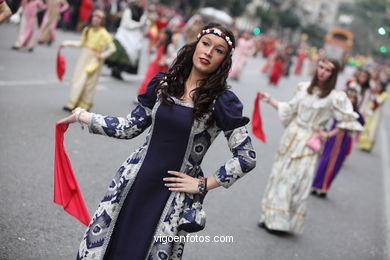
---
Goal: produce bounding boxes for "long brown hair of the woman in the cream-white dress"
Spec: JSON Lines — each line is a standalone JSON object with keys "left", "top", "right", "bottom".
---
{"left": 307, "top": 58, "right": 340, "bottom": 98}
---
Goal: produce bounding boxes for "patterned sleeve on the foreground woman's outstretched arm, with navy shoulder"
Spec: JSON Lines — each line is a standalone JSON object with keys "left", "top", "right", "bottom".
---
{"left": 88, "top": 73, "right": 162, "bottom": 139}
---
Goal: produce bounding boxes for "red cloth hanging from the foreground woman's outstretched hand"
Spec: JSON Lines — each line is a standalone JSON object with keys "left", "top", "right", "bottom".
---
{"left": 54, "top": 124, "right": 91, "bottom": 226}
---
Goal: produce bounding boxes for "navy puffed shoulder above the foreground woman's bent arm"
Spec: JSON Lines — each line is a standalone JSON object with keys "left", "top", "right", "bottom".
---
{"left": 214, "top": 90, "right": 249, "bottom": 131}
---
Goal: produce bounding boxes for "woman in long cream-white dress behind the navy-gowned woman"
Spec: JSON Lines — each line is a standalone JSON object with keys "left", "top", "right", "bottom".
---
{"left": 259, "top": 59, "right": 363, "bottom": 233}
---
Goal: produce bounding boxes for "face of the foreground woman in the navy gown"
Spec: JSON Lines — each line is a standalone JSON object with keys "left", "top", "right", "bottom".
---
{"left": 192, "top": 34, "right": 229, "bottom": 74}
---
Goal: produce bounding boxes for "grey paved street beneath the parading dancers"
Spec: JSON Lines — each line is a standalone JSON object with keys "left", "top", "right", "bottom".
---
{"left": 0, "top": 24, "right": 390, "bottom": 260}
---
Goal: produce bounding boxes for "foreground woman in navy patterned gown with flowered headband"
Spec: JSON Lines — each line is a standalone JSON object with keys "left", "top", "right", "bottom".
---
{"left": 60, "top": 24, "right": 256, "bottom": 260}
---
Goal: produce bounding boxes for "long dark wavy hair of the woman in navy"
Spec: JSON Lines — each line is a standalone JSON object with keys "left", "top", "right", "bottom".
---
{"left": 156, "top": 23, "right": 235, "bottom": 125}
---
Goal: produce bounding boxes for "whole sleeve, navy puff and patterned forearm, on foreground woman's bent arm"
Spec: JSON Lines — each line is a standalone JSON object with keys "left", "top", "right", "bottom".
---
{"left": 214, "top": 91, "right": 256, "bottom": 188}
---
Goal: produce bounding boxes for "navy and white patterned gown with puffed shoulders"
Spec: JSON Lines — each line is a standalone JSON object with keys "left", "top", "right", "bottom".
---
{"left": 77, "top": 73, "right": 256, "bottom": 259}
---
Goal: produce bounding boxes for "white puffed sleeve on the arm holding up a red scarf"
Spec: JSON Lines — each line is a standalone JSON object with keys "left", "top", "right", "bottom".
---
{"left": 278, "top": 82, "right": 310, "bottom": 127}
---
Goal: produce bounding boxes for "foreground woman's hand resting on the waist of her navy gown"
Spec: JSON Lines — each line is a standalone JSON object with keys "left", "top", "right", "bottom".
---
{"left": 163, "top": 171, "right": 199, "bottom": 194}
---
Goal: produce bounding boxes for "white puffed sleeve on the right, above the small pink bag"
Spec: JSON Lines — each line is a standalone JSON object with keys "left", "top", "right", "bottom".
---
{"left": 331, "top": 90, "right": 364, "bottom": 131}
